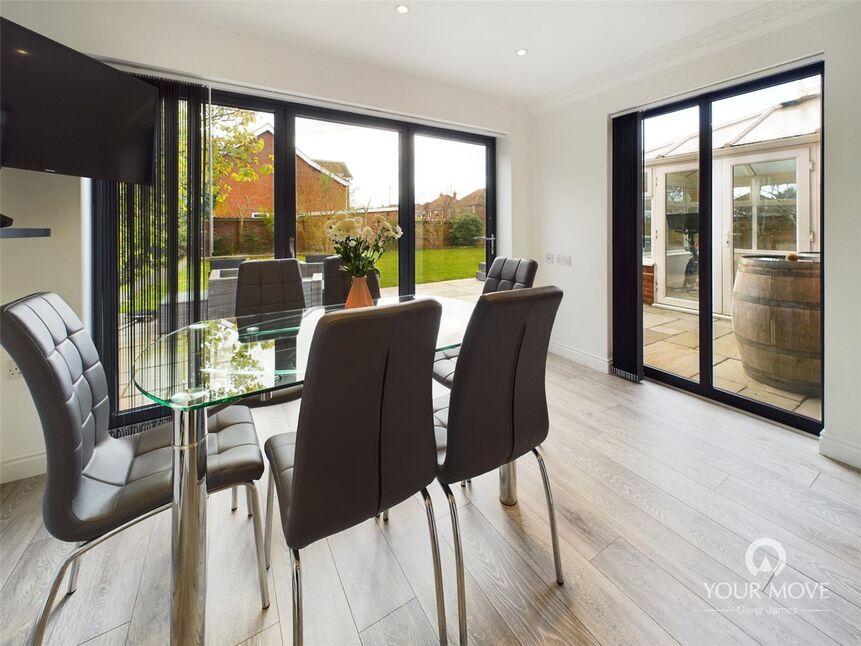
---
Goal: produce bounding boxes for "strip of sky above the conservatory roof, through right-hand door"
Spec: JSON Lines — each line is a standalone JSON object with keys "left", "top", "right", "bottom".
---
{"left": 643, "top": 76, "right": 820, "bottom": 150}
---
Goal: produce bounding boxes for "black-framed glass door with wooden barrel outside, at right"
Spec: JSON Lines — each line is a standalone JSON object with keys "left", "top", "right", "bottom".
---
{"left": 636, "top": 65, "right": 824, "bottom": 433}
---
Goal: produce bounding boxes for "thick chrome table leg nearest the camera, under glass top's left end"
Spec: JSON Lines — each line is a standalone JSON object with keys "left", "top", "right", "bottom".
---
{"left": 170, "top": 409, "right": 207, "bottom": 646}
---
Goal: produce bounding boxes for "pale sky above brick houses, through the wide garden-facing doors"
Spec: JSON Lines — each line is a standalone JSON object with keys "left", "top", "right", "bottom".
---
{"left": 235, "top": 113, "right": 486, "bottom": 206}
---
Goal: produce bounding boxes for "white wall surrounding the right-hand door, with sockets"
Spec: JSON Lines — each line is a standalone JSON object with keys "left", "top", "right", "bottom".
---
{"left": 530, "top": 3, "right": 861, "bottom": 467}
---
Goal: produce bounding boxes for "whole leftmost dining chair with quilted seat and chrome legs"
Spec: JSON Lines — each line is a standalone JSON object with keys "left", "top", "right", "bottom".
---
{"left": 0, "top": 293, "right": 269, "bottom": 644}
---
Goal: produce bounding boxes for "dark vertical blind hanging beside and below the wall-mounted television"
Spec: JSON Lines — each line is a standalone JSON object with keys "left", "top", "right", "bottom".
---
{"left": 93, "top": 76, "right": 209, "bottom": 430}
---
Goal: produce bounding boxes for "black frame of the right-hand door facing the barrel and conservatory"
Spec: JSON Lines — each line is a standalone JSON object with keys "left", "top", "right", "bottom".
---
{"left": 636, "top": 62, "right": 825, "bottom": 435}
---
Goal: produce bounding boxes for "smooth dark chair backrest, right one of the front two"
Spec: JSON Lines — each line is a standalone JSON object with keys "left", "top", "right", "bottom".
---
{"left": 440, "top": 287, "right": 562, "bottom": 482}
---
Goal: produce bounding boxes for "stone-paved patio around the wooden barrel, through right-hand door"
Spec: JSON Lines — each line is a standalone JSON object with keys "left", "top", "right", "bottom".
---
{"left": 643, "top": 305, "right": 822, "bottom": 419}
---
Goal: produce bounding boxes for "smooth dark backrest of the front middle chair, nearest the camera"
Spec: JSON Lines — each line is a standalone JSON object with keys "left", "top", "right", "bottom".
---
{"left": 285, "top": 300, "right": 442, "bottom": 549}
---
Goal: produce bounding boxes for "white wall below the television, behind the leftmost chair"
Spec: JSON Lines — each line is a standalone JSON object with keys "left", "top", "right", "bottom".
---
{"left": 0, "top": 168, "right": 86, "bottom": 482}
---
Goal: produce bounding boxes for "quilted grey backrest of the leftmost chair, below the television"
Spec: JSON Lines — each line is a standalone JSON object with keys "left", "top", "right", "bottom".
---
{"left": 0, "top": 293, "right": 110, "bottom": 538}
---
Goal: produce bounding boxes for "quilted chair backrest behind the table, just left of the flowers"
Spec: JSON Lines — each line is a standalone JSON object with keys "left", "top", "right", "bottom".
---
{"left": 235, "top": 258, "right": 305, "bottom": 316}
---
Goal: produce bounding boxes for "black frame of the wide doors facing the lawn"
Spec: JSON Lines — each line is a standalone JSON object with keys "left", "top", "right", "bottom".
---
{"left": 211, "top": 90, "right": 498, "bottom": 294}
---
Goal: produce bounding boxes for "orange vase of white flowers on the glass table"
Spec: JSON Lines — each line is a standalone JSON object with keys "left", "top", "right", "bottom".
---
{"left": 326, "top": 216, "right": 403, "bottom": 308}
